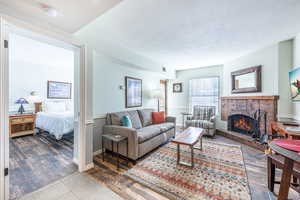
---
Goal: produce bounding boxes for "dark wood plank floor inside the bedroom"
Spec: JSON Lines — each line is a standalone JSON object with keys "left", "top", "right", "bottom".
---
{"left": 9, "top": 133, "right": 77, "bottom": 199}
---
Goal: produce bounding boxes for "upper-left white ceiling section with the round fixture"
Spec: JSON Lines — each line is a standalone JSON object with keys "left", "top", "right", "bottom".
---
{"left": 0, "top": 0, "right": 121, "bottom": 33}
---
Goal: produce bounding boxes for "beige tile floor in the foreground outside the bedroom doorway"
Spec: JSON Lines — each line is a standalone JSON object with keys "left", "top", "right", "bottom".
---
{"left": 20, "top": 172, "right": 122, "bottom": 200}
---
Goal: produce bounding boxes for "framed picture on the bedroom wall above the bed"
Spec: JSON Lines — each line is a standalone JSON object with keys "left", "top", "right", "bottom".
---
{"left": 47, "top": 81, "right": 72, "bottom": 99}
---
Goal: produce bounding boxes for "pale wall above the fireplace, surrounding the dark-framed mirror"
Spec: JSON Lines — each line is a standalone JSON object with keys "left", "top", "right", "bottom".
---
{"left": 223, "top": 40, "right": 293, "bottom": 118}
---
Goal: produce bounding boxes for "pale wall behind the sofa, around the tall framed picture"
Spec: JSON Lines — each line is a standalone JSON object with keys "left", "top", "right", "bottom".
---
{"left": 92, "top": 50, "right": 166, "bottom": 152}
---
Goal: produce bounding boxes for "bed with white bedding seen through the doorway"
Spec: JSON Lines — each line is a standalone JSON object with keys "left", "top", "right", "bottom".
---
{"left": 36, "top": 102, "right": 74, "bottom": 140}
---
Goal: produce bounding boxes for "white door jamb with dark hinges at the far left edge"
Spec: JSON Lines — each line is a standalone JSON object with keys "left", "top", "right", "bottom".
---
{"left": 0, "top": 18, "right": 9, "bottom": 200}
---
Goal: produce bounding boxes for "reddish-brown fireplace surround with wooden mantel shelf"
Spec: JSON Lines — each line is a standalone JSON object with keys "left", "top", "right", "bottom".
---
{"left": 221, "top": 95, "right": 279, "bottom": 132}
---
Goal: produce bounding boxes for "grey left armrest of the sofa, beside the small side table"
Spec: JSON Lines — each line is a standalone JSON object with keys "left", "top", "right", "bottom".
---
{"left": 103, "top": 125, "right": 138, "bottom": 159}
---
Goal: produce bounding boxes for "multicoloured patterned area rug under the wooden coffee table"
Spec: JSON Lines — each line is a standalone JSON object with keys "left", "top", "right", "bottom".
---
{"left": 124, "top": 141, "right": 251, "bottom": 200}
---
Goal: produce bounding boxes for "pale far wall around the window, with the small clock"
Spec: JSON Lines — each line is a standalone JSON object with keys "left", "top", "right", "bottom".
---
{"left": 168, "top": 65, "right": 223, "bottom": 125}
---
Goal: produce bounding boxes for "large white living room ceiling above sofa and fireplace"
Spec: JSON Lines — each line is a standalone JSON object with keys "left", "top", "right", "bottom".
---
{"left": 77, "top": 0, "right": 300, "bottom": 69}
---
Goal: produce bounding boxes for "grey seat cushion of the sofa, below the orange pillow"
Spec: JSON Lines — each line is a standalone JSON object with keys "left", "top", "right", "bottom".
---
{"left": 137, "top": 122, "right": 175, "bottom": 144}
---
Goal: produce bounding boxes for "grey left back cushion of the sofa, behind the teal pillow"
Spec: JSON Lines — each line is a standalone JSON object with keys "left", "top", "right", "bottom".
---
{"left": 110, "top": 110, "right": 142, "bottom": 129}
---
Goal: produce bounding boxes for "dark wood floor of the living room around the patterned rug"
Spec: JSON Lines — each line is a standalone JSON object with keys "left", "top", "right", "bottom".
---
{"left": 87, "top": 132, "right": 299, "bottom": 200}
